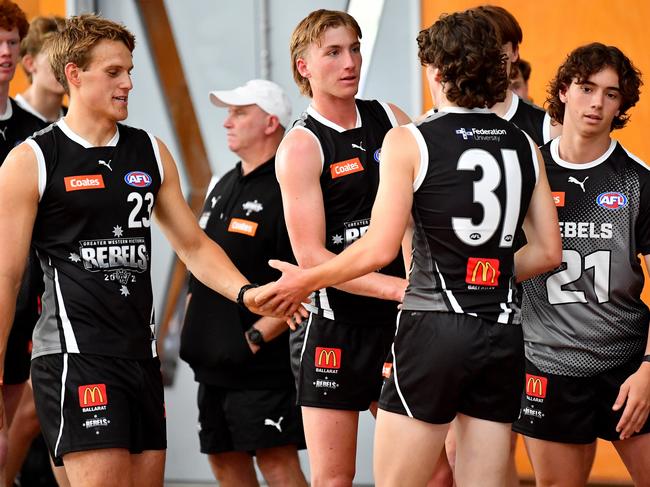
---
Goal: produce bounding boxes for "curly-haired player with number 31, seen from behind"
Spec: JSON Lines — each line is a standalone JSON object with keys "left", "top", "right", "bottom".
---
{"left": 259, "top": 11, "right": 561, "bottom": 486}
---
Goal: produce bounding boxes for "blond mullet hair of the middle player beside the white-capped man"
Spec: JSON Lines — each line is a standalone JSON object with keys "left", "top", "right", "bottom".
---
{"left": 289, "top": 9, "right": 361, "bottom": 97}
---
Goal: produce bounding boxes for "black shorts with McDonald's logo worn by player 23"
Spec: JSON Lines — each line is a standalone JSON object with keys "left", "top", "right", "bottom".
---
{"left": 32, "top": 353, "right": 167, "bottom": 466}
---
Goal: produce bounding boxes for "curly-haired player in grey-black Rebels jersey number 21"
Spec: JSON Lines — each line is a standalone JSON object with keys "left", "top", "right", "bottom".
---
{"left": 514, "top": 43, "right": 650, "bottom": 486}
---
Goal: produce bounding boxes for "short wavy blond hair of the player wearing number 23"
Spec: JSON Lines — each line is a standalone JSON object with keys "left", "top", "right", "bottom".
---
{"left": 47, "top": 14, "right": 135, "bottom": 93}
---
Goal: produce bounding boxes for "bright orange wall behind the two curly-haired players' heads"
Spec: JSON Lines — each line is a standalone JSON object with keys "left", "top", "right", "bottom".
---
{"left": 414, "top": 0, "right": 650, "bottom": 163}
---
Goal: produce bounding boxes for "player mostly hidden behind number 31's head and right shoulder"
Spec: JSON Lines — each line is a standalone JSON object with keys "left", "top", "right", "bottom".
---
{"left": 476, "top": 5, "right": 562, "bottom": 146}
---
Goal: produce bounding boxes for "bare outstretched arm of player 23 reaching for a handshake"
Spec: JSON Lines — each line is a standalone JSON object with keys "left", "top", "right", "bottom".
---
{"left": 154, "top": 141, "right": 297, "bottom": 316}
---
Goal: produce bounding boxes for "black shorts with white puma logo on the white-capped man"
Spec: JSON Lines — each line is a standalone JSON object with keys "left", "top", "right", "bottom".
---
{"left": 197, "top": 384, "right": 305, "bottom": 455}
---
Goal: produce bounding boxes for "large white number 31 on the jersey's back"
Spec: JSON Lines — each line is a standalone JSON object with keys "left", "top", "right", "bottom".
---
{"left": 451, "top": 149, "right": 521, "bottom": 247}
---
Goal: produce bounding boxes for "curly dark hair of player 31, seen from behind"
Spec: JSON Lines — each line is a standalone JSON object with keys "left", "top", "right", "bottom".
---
{"left": 417, "top": 10, "right": 508, "bottom": 108}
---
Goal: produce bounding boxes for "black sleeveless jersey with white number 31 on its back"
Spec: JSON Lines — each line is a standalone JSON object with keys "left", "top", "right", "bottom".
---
{"left": 402, "top": 107, "right": 539, "bottom": 324}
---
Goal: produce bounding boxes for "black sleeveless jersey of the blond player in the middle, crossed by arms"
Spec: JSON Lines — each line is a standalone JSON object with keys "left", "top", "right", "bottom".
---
{"left": 292, "top": 100, "right": 405, "bottom": 324}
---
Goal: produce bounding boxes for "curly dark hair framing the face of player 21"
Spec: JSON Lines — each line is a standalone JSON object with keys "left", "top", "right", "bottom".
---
{"left": 546, "top": 42, "right": 643, "bottom": 130}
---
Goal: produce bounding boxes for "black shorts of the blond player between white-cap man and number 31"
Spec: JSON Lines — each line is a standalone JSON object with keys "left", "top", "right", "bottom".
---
{"left": 289, "top": 313, "right": 395, "bottom": 411}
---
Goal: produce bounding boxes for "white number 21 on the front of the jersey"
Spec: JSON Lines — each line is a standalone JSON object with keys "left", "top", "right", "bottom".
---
{"left": 546, "top": 250, "right": 611, "bottom": 304}
